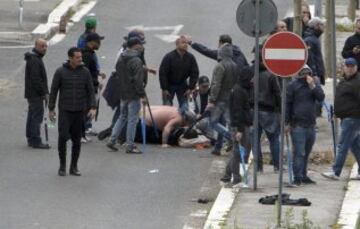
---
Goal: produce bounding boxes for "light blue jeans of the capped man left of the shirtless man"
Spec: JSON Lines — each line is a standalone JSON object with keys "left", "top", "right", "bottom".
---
{"left": 110, "top": 99, "right": 140, "bottom": 148}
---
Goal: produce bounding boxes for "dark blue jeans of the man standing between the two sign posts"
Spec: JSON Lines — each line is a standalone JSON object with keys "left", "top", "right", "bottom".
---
{"left": 252, "top": 111, "right": 280, "bottom": 170}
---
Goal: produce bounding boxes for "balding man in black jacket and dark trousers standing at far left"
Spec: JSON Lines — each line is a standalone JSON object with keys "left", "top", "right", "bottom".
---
{"left": 25, "top": 39, "right": 50, "bottom": 149}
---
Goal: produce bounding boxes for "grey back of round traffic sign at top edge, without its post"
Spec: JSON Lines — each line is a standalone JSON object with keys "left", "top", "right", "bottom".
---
{"left": 236, "top": 0, "right": 278, "bottom": 37}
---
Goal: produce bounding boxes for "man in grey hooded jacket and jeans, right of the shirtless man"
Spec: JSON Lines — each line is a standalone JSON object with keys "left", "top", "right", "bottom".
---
{"left": 206, "top": 43, "right": 237, "bottom": 155}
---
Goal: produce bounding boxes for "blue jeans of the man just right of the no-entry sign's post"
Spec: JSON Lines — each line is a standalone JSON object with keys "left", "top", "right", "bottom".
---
{"left": 291, "top": 126, "right": 315, "bottom": 181}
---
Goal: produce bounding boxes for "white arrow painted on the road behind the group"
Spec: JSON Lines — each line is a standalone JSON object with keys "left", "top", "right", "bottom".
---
{"left": 125, "top": 24, "right": 184, "bottom": 43}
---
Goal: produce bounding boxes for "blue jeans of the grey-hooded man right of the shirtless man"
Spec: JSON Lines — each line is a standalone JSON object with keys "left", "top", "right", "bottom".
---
{"left": 210, "top": 102, "right": 232, "bottom": 150}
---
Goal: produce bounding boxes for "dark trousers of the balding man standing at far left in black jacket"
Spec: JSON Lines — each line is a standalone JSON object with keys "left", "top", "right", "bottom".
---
{"left": 26, "top": 98, "right": 44, "bottom": 145}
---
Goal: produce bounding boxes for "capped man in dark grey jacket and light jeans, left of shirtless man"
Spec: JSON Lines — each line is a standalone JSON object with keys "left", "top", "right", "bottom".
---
{"left": 106, "top": 37, "right": 146, "bottom": 154}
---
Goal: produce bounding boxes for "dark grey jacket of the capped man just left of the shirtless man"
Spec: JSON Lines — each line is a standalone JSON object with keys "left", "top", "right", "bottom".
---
{"left": 116, "top": 49, "right": 145, "bottom": 100}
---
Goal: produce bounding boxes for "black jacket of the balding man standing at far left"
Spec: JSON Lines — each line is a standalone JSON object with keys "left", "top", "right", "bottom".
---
{"left": 24, "top": 49, "right": 49, "bottom": 99}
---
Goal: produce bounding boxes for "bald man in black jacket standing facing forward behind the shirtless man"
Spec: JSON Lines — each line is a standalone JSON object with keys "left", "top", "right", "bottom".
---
{"left": 159, "top": 36, "right": 199, "bottom": 107}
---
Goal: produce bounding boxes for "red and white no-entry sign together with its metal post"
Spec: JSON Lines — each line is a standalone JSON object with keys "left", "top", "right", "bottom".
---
{"left": 262, "top": 32, "right": 308, "bottom": 227}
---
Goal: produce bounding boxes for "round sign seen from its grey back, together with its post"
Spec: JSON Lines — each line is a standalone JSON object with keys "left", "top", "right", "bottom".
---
{"left": 236, "top": 0, "right": 278, "bottom": 190}
